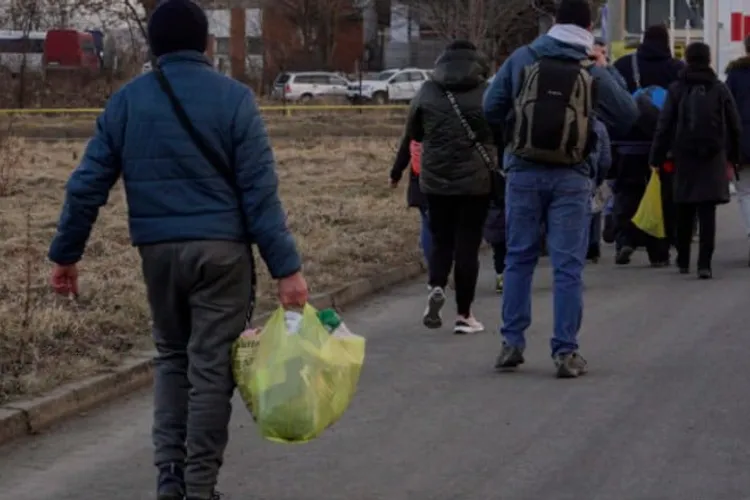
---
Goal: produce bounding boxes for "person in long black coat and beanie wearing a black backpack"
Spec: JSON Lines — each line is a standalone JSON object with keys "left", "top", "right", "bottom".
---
{"left": 650, "top": 42, "right": 742, "bottom": 279}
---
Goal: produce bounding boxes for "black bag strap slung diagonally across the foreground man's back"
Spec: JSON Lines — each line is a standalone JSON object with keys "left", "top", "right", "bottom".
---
{"left": 152, "top": 61, "right": 258, "bottom": 326}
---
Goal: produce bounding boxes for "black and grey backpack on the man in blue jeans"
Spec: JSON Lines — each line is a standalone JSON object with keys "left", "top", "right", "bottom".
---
{"left": 509, "top": 53, "right": 594, "bottom": 166}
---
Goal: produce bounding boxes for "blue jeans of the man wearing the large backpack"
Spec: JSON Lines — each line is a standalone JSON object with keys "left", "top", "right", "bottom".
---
{"left": 500, "top": 168, "right": 591, "bottom": 356}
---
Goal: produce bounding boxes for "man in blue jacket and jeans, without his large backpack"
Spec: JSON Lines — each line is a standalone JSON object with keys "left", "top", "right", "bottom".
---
{"left": 484, "top": 0, "right": 638, "bottom": 378}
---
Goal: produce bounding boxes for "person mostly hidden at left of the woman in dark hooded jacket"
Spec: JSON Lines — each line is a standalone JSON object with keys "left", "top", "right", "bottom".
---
{"left": 391, "top": 137, "right": 432, "bottom": 265}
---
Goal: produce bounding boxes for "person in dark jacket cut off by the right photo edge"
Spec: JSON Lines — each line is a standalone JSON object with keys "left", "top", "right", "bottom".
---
{"left": 726, "top": 37, "right": 750, "bottom": 266}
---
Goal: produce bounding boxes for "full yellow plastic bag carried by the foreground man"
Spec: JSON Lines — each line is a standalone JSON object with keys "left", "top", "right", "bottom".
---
{"left": 247, "top": 305, "right": 365, "bottom": 443}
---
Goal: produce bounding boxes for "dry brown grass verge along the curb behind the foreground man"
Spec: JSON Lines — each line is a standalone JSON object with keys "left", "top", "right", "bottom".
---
{"left": 0, "top": 137, "right": 419, "bottom": 403}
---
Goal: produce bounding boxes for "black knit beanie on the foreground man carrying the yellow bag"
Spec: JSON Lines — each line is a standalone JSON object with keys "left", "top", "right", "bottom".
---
{"left": 148, "top": 0, "right": 208, "bottom": 57}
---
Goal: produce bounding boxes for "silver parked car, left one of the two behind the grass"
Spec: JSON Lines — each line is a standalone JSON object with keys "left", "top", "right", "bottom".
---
{"left": 271, "top": 71, "right": 349, "bottom": 102}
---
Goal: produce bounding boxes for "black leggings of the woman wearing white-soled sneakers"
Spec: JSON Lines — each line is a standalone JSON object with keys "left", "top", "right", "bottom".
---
{"left": 427, "top": 194, "right": 490, "bottom": 316}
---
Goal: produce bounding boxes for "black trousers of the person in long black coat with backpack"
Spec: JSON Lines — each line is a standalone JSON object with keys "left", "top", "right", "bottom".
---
{"left": 677, "top": 203, "right": 716, "bottom": 270}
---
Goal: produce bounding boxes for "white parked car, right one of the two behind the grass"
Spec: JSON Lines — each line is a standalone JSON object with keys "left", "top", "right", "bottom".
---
{"left": 346, "top": 68, "right": 432, "bottom": 104}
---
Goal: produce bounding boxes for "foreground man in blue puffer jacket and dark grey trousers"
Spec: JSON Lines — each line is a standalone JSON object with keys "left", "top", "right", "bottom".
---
{"left": 49, "top": 0, "right": 307, "bottom": 500}
